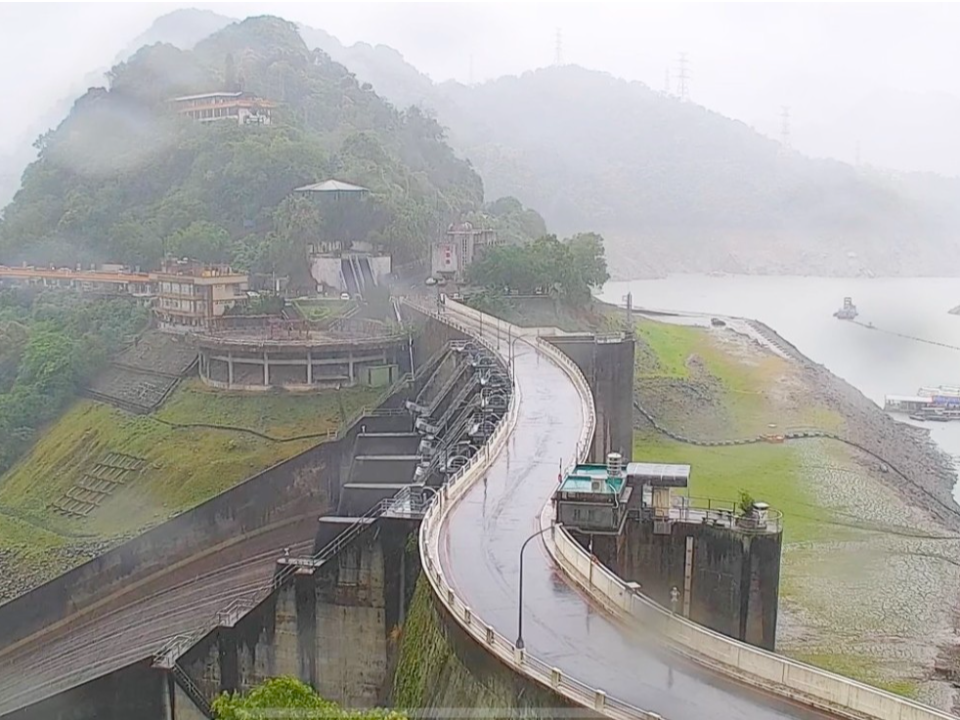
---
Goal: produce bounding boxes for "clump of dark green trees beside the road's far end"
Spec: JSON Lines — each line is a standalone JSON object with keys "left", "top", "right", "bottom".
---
{"left": 468, "top": 233, "right": 609, "bottom": 305}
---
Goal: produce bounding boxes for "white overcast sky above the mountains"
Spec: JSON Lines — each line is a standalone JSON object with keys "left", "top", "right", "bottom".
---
{"left": 0, "top": 2, "right": 960, "bottom": 172}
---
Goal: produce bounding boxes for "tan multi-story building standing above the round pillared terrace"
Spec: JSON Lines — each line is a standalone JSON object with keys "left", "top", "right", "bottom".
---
{"left": 150, "top": 261, "right": 249, "bottom": 329}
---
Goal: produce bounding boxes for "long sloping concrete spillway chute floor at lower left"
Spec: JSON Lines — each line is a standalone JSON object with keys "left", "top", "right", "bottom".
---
{"left": 0, "top": 512, "right": 317, "bottom": 717}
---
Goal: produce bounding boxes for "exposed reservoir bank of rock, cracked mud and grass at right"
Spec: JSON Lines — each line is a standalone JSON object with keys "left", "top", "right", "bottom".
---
{"left": 635, "top": 311, "right": 960, "bottom": 710}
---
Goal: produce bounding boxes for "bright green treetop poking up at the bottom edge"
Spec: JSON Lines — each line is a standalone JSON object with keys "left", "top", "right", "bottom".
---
{"left": 213, "top": 677, "right": 406, "bottom": 720}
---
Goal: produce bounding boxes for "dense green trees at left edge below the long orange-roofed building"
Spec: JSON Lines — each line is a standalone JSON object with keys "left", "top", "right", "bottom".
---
{"left": 0, "top": 289, "right": 146, "bottom": 472}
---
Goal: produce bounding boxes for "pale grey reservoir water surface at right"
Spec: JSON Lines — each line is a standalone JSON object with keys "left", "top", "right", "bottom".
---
{"left": 600, "top": 275, "right": 960, "bottom": 503}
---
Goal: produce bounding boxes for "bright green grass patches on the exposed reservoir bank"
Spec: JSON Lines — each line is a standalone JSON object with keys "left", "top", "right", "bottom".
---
{"left": 633, "top": 321, "right": 917, "bottom": 696}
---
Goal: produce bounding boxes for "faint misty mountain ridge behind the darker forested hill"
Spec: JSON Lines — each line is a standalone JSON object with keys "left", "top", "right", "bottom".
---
{"left": 5, "top": 10, "right": 960, "bottom": 277}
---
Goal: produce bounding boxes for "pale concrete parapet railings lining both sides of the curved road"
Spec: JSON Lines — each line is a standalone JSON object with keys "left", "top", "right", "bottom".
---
{"left": 421, "top": 296, "right": 954, "bottom": 720}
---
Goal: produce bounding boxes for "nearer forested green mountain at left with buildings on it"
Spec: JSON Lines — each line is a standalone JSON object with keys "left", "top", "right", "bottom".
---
{"left": 0, "top": 17, "right": 542, "bottom": 276}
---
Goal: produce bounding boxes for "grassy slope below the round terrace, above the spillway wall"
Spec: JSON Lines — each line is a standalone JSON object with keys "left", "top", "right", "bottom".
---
{"left": 0, "top": 381, "right": 381, "bottom": 559}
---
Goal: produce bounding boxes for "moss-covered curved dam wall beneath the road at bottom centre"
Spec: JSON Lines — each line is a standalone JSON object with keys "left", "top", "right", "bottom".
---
{"left": 391, "top": 578, "right": 584, "bottom": 718}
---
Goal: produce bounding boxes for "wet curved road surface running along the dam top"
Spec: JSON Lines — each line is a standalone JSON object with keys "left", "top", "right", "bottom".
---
{"left": 440, "top": 304, "right": 827, "bottom": 720}
